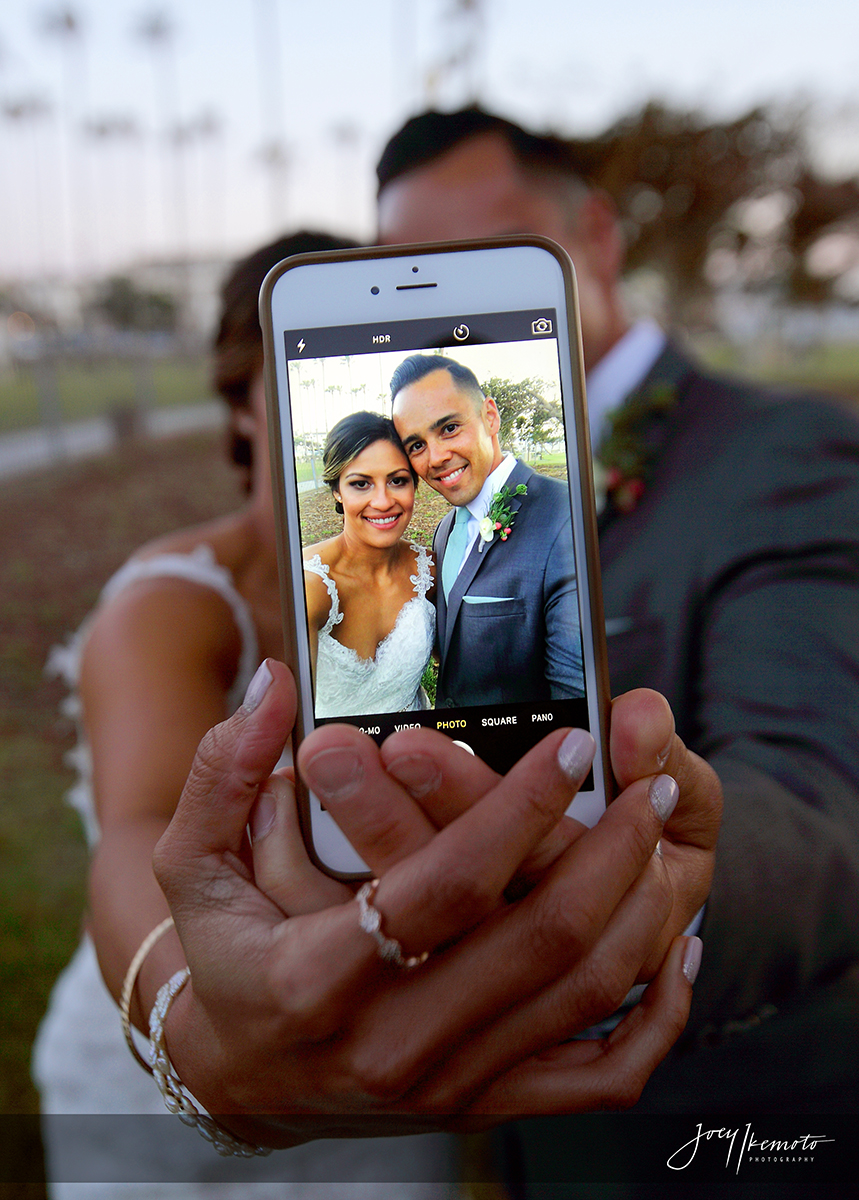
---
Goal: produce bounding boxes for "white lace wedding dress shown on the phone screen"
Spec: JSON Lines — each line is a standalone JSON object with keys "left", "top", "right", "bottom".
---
{"left": 305, "top": 542, "right": 435, "bottom": 716}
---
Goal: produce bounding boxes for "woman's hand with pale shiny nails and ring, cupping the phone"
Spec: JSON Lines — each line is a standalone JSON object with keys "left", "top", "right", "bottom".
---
{"left": 149, "top": 662, "right": 699, "bottom": 1145}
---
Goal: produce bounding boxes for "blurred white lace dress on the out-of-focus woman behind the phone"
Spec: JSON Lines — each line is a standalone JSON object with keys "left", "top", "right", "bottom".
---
{"left": 32, "top": 545, "right": 458, "bottom": 1200}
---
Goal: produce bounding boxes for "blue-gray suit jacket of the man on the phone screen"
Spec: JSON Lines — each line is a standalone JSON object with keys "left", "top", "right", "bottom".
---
{"left": 433, "top": 462, "right": 584, "bottom": 708}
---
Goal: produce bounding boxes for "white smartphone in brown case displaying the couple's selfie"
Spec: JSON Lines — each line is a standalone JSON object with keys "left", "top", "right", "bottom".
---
{"left": 260, "top": 236, "right": 611, "bottom": 878}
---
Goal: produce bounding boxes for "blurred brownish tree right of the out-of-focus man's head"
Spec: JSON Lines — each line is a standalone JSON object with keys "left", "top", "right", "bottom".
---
{"left": 563, "top": 102, "right": 859, "bottom": 322}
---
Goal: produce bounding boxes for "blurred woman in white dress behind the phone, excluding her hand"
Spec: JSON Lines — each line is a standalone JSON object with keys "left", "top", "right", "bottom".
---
{"left": 34, "top": 234, "right": 456, "bottom": 1200}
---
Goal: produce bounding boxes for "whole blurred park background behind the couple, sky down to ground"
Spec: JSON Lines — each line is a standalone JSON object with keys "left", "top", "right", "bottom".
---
{"left": 0, "top": 0, "right": 859, "bottom": 1196}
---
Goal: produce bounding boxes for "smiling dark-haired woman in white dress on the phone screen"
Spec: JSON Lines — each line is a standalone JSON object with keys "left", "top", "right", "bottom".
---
{"left": 305, "top": 413, "right": 435, "bottom": 718}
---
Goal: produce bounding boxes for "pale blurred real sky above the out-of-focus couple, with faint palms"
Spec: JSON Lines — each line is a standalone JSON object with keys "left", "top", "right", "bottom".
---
{"left": 0, "top": 0, "right": 859, "bottom": 281}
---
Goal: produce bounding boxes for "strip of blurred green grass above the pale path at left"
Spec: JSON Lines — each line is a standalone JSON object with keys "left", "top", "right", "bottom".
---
{"left": 0, "top": 358, "right": 211, "bottom": 433}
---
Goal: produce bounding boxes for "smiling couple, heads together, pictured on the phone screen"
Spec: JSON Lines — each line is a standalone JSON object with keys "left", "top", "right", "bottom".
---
{"left": 298, "top": 353, "right": 584, "bottom": 719}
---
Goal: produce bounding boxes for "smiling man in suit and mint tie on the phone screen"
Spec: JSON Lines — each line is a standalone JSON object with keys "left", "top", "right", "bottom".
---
{"left": 391, "top": 354, "right": 584, "bottom": 708}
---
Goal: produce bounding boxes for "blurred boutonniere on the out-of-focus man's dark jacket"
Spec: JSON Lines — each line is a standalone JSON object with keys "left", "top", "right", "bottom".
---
{"left": 594, "top": 383, "right": 678, "bottom": 512}
